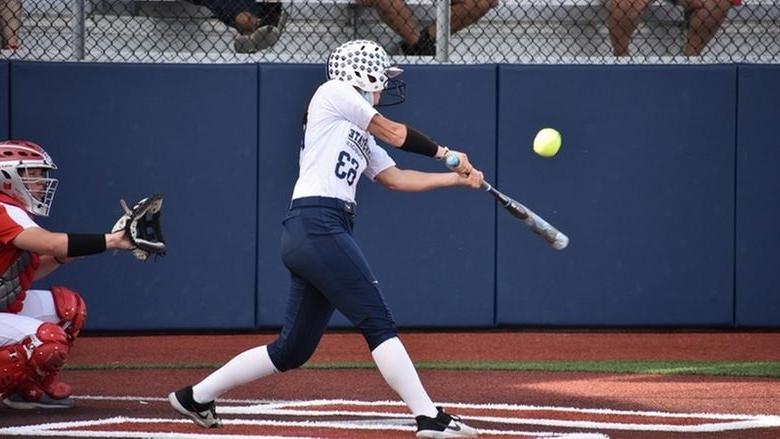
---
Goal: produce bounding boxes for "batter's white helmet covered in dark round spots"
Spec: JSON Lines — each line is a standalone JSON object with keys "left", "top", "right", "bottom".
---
{"left": 328, "top": 40, "right": 403, "bottom": 91}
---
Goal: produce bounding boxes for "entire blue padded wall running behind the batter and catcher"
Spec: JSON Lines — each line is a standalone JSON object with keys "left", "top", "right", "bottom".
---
{"left": 0, "top": 61, "right": 780, "bottom": 331}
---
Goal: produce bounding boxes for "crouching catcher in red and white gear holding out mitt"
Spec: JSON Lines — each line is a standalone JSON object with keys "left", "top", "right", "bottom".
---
{"left": 0, "top": 140, "right": 165, "bottom": 409}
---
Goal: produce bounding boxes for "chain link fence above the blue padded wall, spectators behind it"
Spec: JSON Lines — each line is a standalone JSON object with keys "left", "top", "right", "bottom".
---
{"left": 0, "top": 0, "right": 780, "bottom": 64}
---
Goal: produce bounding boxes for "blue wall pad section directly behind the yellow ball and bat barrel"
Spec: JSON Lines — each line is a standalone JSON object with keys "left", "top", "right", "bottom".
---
{"left": 496, "top": 66, "right": 736, "bottom": 326}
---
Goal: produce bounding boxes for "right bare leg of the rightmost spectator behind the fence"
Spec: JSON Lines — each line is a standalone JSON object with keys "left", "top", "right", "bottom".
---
{"left": 680, "top": 0, "right": 731, "bottom": 56}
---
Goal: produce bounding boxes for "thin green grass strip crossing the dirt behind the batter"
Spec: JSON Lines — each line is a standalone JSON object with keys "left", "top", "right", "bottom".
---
{"left": 66, "top": 360, "right": 780, "bottom": 378}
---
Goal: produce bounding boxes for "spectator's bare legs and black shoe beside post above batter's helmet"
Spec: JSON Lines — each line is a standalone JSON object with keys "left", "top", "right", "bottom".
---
{"left": 357, "top": 0, "right": 498, "bottom": 56}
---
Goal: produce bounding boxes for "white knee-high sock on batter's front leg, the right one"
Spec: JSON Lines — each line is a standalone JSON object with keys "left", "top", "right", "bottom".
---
{"left": 371, "top": 337, "right": 438, "bottom": 418}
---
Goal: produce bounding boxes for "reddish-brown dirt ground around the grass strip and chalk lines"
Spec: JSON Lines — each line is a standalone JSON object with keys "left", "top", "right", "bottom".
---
{"left": 0, "top": 331, "right": 780, "bottom": 439}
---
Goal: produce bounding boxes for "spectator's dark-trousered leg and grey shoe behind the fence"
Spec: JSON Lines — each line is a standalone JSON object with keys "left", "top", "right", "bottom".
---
{"left": 187, "top": 0, "right": 287, "bottom": 53}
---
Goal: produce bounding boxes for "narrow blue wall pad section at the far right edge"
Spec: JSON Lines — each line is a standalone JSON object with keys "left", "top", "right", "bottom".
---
{"left": 736, "top": 66, "right": 780, "bottom": 327}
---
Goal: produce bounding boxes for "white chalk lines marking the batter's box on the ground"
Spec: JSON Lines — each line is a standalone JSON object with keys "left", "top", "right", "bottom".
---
{"left": 0, "top": 395, "right": 780, "bottom": 439}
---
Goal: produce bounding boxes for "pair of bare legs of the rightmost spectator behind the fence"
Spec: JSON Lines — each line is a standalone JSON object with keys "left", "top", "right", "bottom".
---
{"left": 606, "top": 0, "right": 740, "bottom": 56}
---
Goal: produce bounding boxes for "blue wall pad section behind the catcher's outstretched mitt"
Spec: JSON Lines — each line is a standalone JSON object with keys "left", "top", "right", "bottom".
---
{"left": 11, "top": 63, "right": 258, "bottom": 329}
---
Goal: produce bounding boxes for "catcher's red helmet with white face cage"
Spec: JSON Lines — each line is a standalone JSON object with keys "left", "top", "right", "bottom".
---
{"left": 0, "top": 140, "right": 58, "bottom": 216}
